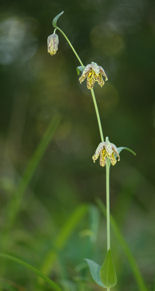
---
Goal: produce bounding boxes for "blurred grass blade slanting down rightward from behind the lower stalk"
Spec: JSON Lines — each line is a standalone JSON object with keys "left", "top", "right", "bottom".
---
{"left": 97, "top": 199, "right": 149, "bottom": 291}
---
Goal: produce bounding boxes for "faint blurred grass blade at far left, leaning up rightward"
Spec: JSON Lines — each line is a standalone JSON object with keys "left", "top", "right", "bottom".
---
{"left": 4, "top": 115, "right": 60, "bottom": 230}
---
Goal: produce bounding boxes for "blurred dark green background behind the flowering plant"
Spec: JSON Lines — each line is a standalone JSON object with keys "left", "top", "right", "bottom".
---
{"left": 0, "top": 0, "right": 155, "bottom": 291}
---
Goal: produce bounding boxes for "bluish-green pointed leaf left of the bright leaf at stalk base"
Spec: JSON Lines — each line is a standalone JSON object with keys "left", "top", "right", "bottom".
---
{"left": 85, "top": 259, "right": 106, "bottom": 288}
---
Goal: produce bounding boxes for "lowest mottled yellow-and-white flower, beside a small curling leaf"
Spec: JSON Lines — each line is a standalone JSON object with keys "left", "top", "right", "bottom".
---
{"left": 92, "top": 138, "right": 120, "bottom": 167}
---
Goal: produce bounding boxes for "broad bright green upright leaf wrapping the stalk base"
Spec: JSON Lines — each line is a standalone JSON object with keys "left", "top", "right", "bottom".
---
{"left": 100, "top": 250, "right": 117, "bottom": 288}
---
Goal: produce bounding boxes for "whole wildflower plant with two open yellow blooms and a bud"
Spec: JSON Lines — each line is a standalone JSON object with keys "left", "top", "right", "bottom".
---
{"left": 47, "top": 11, "right": 135, "bottom": 291}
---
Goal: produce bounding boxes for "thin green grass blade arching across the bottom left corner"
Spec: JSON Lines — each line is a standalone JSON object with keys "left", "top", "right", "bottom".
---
{"left": 0, "top": 253, "right": 62, "bottom": 291}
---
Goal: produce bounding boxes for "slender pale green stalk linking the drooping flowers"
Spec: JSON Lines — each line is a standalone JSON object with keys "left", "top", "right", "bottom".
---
{"left": 56, "top": 26, "right": 110, "bottom": 291}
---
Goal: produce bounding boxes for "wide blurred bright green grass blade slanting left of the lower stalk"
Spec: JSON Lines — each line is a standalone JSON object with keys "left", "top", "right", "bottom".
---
{"left": 41, "top": 205, "right": 88, "bottom": 275}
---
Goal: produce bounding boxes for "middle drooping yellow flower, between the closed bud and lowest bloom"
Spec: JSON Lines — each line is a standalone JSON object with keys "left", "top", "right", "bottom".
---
{"left": 79, "top": 62, "right": 108, "bottom": 89}
